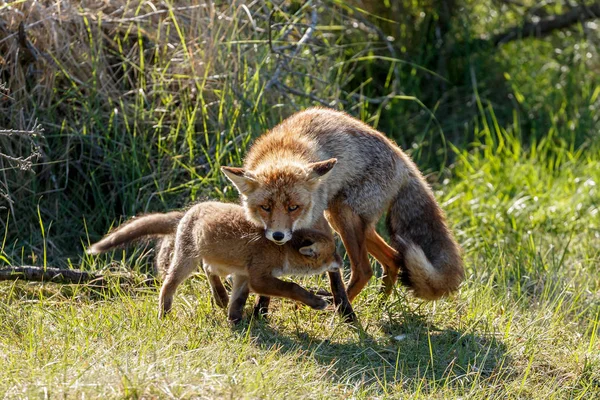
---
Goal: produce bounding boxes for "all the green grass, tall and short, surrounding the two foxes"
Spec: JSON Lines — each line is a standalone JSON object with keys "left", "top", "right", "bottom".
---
{"left": 0, "top": 1, "right": 600, "bottom": 399}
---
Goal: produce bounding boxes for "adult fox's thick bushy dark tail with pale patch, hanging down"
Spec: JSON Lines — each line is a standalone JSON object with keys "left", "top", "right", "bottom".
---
{"left": 387, "top": 176, "right": 464, "bottom": 300}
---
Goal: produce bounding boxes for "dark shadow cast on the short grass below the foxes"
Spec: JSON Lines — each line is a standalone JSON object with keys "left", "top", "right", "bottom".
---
{"left": 239, "top": 315, "right": 511, "bottom": 391}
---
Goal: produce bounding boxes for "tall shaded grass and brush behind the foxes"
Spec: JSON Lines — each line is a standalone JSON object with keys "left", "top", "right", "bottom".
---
{"left": 0, "top": 0, "right": 600, "bottom": 266}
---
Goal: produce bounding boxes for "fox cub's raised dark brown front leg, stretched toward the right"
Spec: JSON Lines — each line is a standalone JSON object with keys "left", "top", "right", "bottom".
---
{"left": 249, "top": 275, "right": 327, "bottom": 310}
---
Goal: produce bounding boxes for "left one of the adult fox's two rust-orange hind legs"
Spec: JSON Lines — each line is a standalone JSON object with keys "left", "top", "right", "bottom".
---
{"left": 327, "top": 201, "right": 373, "bottom": 301}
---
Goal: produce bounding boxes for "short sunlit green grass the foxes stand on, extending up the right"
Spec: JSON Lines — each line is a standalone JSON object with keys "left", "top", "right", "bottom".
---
{"left": 0, "top": 122, "right": 600, "bottom": 399}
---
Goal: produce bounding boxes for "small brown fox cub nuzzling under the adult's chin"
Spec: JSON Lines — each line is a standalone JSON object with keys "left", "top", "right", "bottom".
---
{"left": 88, "top": 202, "right": 344, "bottom": 322}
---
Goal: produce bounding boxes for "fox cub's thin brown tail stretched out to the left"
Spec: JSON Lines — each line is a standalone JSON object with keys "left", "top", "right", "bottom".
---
{"left": 87, "top": 211, "right": 184, "bottom": 254}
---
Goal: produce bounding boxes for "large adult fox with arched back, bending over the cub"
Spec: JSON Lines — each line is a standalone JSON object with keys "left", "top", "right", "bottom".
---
{"left": 222, "top": 108, "right": 464, "bottom": 301}
